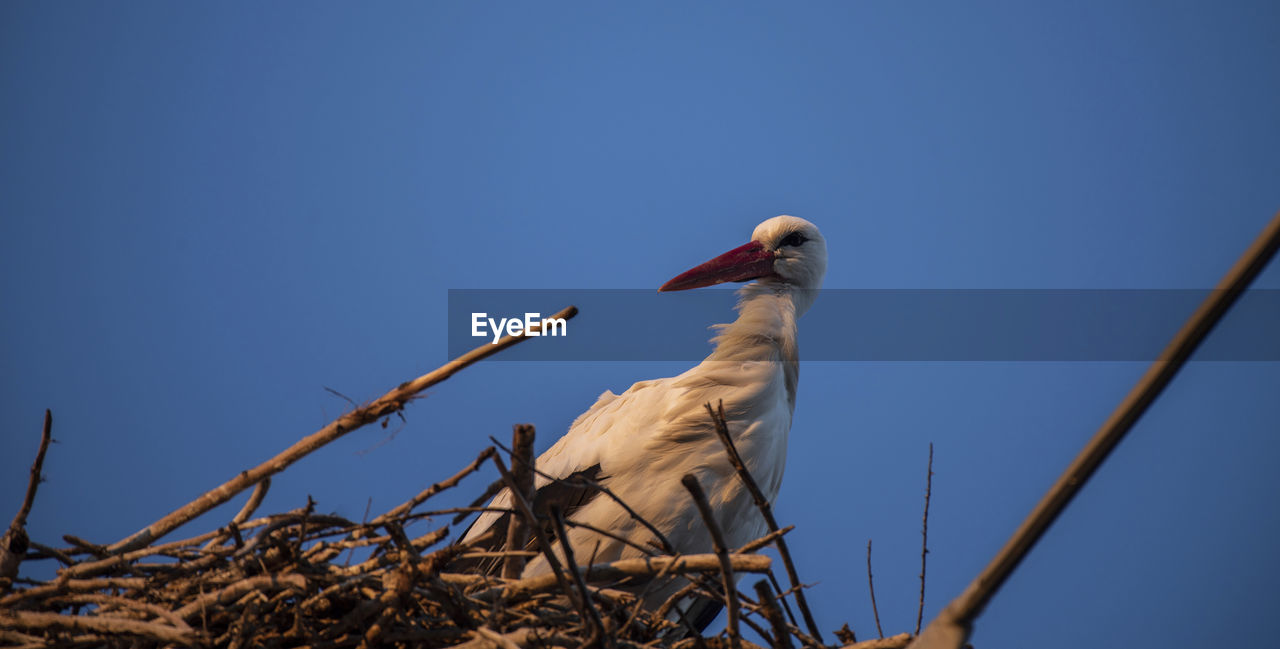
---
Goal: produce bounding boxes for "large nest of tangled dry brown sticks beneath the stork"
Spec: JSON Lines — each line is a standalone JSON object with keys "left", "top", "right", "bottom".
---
{"left": 0, "top": 312, "right": 910, "bottom": 649}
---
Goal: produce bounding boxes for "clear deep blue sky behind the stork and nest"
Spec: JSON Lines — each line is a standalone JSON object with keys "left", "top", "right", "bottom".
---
{"left": 0, "top": 0, "right": 1280, "bottom": 649}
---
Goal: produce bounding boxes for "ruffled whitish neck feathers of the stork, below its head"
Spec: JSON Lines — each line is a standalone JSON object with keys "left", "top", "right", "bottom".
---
{"left": 707, "top": 279, "right": 813, "bottom": 407}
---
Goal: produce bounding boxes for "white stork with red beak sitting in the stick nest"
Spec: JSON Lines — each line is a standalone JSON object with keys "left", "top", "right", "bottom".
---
{"left": 462, "top": 216, "right": 827, "bottom": 630}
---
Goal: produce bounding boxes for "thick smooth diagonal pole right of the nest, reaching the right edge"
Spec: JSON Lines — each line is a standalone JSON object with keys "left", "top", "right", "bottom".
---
{"left": 913, "top": 212, "right": 1280, "bottom": 648}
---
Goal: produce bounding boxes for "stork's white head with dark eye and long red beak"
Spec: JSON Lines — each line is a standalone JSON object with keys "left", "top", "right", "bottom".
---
{"left": 658, "top": 215, "right": 827, "bottom": 291}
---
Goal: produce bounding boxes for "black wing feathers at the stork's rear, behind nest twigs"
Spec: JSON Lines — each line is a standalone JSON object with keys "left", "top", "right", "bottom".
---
{"left": 452, "top": 465, "right": 605, "bottom": 575}
